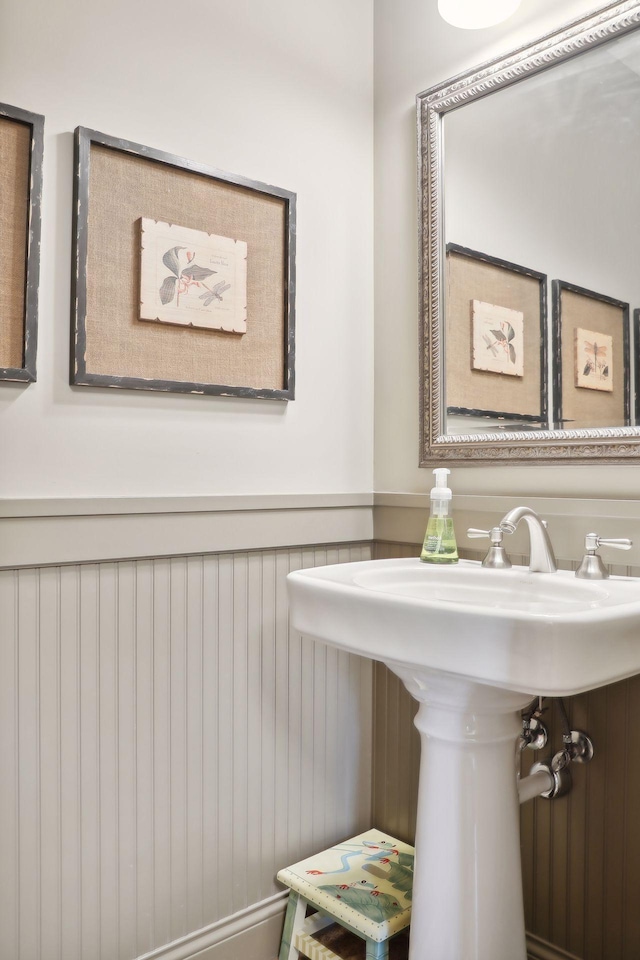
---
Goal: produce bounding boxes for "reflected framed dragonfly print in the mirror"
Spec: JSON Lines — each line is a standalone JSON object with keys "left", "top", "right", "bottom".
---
{"left": 551, "top": 280, "right": 631, "bottom": 430}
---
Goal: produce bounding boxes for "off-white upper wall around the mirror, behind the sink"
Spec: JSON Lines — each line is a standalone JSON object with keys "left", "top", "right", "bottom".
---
{"left": 375, "top": 0, "right": 640, "bottom": 497}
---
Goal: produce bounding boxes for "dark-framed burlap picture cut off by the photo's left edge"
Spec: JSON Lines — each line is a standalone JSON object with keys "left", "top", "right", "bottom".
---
{"left": 0, "top": 104, "right": 44, "bottom": 383}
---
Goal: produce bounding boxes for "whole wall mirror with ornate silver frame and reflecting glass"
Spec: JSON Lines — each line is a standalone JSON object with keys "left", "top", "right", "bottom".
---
{"left": 418, "top": 0, "right": 640, "bottom": 465}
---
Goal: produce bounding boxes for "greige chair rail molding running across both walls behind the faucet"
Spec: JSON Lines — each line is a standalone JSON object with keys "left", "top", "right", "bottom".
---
{"left": 0, "top": 493, "right": 640, "bottom": 569}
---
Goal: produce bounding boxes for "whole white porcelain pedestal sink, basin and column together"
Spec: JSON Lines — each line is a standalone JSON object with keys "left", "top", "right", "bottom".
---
{"left": 288, "top": 559, "right": 640, "bottom": 960}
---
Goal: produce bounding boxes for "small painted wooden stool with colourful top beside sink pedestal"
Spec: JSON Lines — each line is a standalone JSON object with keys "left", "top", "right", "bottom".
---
{"left": 278, "top": 830, "right": 414, "bottom": 960}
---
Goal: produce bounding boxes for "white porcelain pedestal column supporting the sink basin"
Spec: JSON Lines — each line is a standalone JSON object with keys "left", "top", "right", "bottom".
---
{"left": 388, "top": 663, "right": 532, "bottom": 960}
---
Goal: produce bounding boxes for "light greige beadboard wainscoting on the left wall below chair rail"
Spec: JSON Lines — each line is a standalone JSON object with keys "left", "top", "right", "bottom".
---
{"left": 0, "top": 543, "right": 373, "bottom": 960}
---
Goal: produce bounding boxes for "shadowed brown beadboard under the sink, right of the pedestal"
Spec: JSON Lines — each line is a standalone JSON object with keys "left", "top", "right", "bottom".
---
{"left": 522, "top": 677, "right": 640, "bottom": 960}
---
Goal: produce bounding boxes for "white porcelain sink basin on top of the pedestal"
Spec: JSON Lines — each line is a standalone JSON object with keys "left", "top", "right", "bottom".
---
{"left": 289, "top": 559, "right": 640, "bottom": 696}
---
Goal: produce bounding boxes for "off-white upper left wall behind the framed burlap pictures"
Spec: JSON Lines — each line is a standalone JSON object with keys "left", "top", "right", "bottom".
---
{"left": 0, "top": 0, "right": 373, "bottom": 497}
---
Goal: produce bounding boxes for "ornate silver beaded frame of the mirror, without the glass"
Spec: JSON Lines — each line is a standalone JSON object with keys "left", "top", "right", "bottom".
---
{"left": 417, "top": 0, "right": 640, "bottom": 466}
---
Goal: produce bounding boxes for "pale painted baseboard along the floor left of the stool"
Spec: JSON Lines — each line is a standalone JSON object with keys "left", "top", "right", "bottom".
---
{"left": 137, "top": 891, "right": 288, "bottom": 960}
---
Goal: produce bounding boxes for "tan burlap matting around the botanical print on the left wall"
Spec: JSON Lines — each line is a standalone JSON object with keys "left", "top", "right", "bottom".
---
{"left": 86, "top": 144, "right": 287, "bottom": 390}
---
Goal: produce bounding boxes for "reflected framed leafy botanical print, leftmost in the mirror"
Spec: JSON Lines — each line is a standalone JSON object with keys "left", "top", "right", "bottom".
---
{"left": 445, "top": 243, "right": 548, "bottom": 429}
